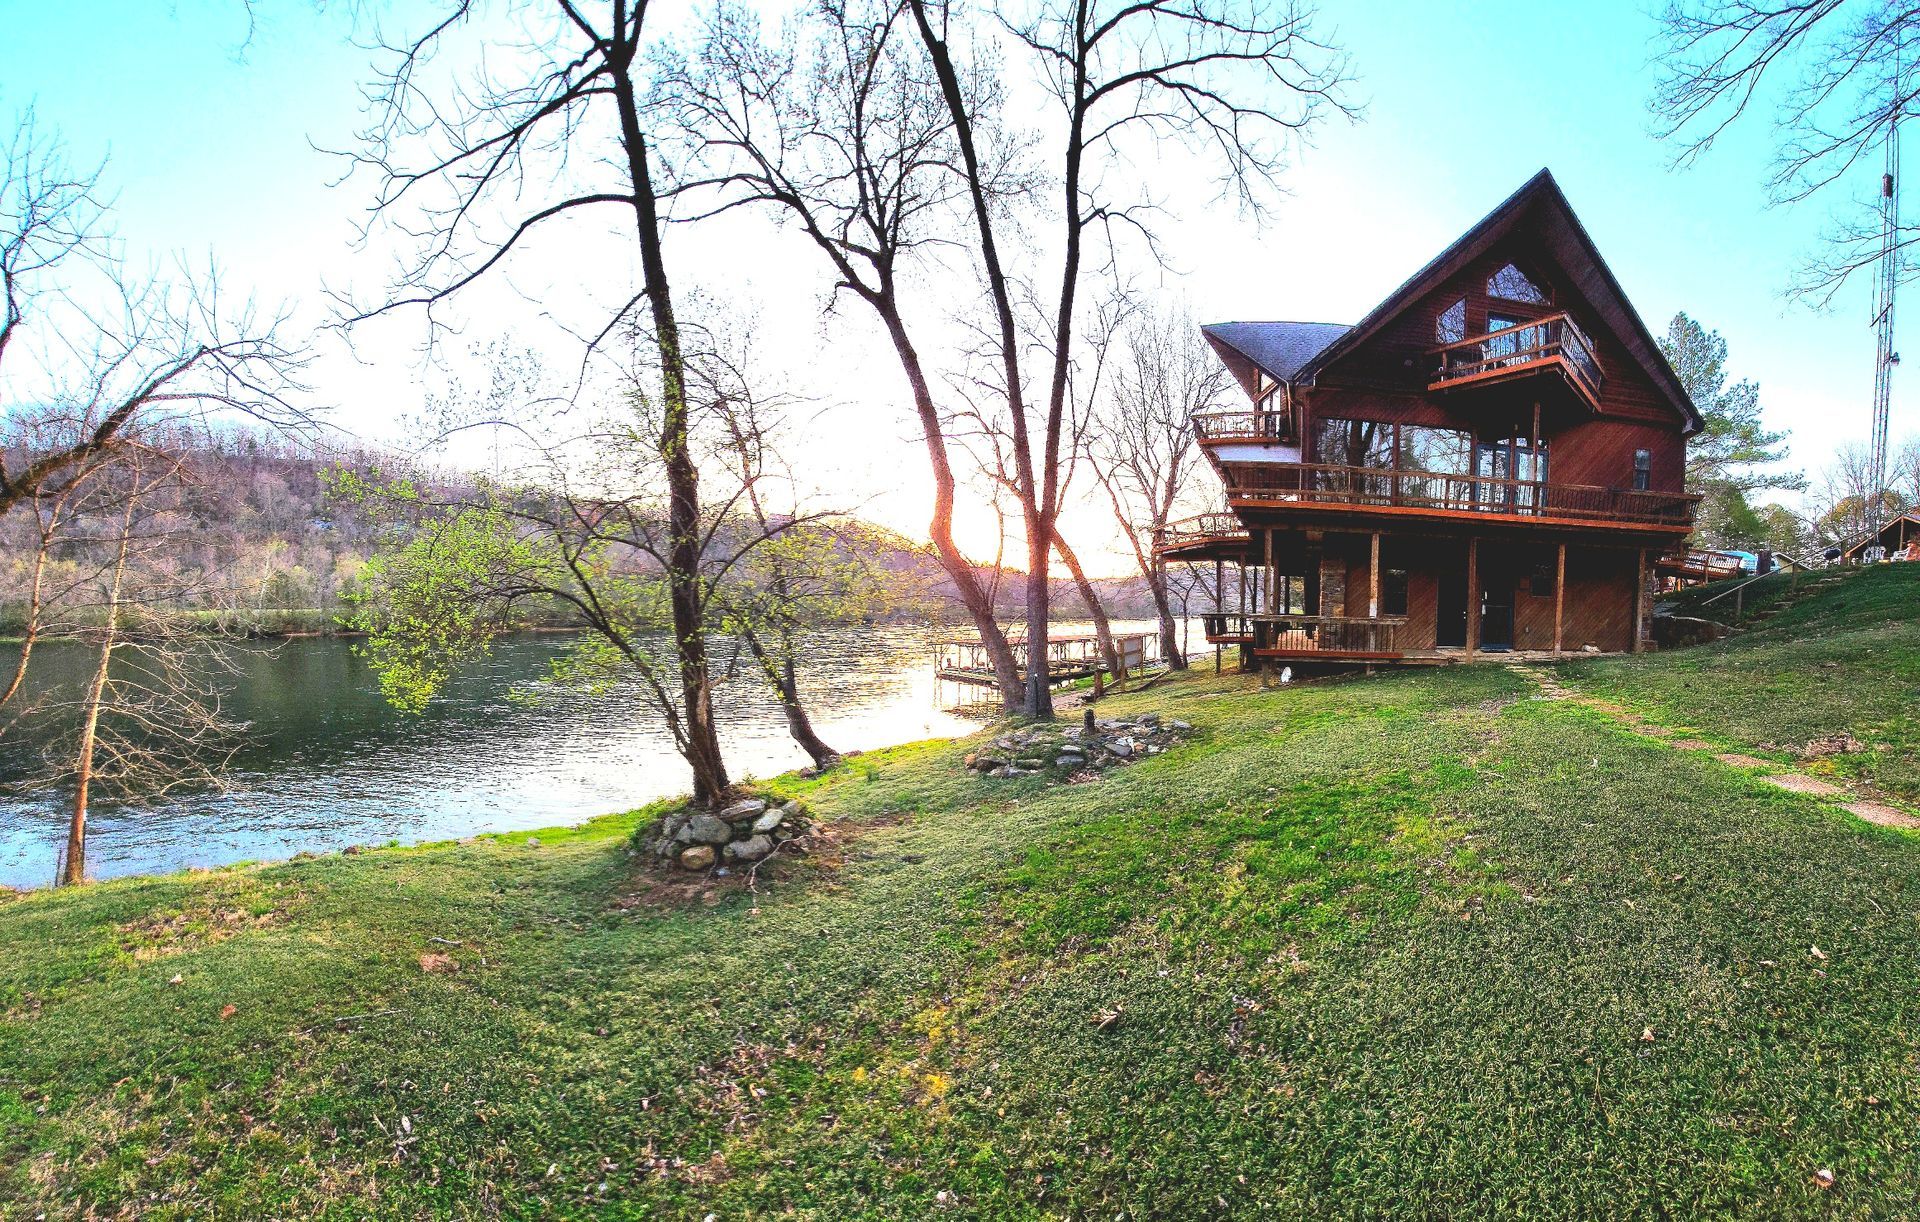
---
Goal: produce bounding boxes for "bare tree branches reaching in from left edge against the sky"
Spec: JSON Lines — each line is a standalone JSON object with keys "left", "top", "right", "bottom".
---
{"left": 0, "top": 113, "right": 307, "bottom": 517}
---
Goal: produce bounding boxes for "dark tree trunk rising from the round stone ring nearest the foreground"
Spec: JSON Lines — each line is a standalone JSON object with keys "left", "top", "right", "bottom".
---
{"left": 607, "top": 52, "right": 730, "bottom": 803}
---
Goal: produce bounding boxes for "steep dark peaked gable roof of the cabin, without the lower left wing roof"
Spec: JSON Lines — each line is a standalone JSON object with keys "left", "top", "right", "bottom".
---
{"left": 1282, "top": 169, "right": 1703, "bottom": 432}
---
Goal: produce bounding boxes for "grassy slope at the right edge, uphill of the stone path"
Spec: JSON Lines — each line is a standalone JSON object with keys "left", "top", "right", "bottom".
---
{"left": 1567, "top": 565, "right": 1920, "bottom": 803}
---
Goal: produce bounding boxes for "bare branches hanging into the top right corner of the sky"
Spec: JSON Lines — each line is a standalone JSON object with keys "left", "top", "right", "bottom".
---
{"left": 1653, "top": 0, "right": 1920, "bottom": 304}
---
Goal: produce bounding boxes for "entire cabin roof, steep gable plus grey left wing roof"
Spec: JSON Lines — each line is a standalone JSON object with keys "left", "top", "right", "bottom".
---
{"left": 1202, "top": 169, "right": 1701, "bottom": 432}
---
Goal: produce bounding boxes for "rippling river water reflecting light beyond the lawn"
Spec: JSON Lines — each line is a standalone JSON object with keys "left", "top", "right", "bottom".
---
{"left": 0, "top": 626, "right": 1182, "bottom": 888}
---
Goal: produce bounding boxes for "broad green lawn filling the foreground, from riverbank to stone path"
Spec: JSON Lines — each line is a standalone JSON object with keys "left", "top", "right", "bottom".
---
{"left": 0, "top": 567, "right": 1920, "bottom": 1220}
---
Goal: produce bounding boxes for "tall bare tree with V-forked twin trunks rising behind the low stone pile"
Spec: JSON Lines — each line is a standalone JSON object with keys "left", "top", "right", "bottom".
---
{"left": 906, "top": 0, "right": 1346, "bottom": 719}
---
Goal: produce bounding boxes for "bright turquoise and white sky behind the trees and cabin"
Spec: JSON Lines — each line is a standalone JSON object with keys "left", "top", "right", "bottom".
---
{"left": 0, "top": 0, "right": 1889, "bottom": 568}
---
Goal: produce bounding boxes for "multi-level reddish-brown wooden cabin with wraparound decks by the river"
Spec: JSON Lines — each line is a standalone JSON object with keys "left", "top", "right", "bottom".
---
{"left": 1154, "top": 169, "right": 1701, "bottom": 665}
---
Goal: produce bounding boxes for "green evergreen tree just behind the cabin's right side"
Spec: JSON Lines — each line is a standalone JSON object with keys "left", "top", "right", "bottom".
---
{"left": 1661, "top": 313, "right": 1807, "bottom": 548}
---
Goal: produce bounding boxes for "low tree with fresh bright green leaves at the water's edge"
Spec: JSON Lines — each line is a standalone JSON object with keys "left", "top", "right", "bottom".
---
{"left": 349, "top": 334, "right": 877, "bottom": 791}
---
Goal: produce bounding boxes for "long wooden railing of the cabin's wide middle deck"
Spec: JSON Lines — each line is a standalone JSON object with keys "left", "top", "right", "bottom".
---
{"left": 1227, "top": 463, "right": 1699, "bottom": 526}
